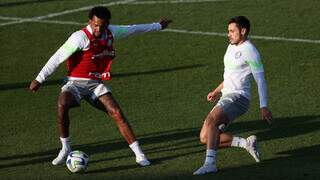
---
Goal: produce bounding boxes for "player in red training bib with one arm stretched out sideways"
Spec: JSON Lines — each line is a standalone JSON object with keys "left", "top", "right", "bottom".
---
{"left": 29, "top": 6, "right": 171, "bottom": 166}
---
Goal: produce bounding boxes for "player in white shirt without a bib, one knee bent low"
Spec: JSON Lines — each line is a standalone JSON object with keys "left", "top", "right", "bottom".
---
{"left": 193, "top": 16, "right": 272, "bottom": 175}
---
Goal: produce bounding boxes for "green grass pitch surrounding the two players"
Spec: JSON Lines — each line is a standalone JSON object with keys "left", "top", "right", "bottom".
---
{"left": 0, "top": 0, "right": 320, "bottom": 180}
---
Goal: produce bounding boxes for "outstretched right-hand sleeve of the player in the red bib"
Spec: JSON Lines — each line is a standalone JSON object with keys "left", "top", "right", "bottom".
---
{"left": 108, "top": 23, "right": 161, "bottom": 39}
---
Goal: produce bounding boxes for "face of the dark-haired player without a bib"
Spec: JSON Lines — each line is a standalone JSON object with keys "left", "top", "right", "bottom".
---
{"left": 228, "top": 23, "right": 246, "bottom": 45}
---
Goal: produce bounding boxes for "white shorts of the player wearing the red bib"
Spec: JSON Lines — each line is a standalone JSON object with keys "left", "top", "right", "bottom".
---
{"left": 61, "top": 79, "right": 111, "bottom": 105}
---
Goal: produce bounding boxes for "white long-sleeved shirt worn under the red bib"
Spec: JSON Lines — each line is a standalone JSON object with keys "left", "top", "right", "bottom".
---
{"left": 36, "top": 23, "right": 161, "bottom": 83}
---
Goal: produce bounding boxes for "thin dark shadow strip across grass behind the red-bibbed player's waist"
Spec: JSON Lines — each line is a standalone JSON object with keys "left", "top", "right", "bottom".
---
{"left": 0, "top": 64, "right": 207, "bottom": 91}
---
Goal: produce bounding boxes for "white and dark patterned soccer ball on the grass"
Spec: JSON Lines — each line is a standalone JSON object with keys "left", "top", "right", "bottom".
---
{"left": 66, "top": 150, "right": 89, "bottom": 173}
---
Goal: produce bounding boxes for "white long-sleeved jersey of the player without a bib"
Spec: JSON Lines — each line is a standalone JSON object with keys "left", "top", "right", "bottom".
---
{"left": 221, "top": 40, "right": 267, "bottom": 107}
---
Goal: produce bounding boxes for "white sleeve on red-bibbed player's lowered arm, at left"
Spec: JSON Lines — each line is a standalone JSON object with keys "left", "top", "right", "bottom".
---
{"left": 36, "top": 31, "right": 85, "bottom": 83}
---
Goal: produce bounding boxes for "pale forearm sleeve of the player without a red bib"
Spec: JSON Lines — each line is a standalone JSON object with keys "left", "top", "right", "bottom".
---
{"left": 253, "top": 72, "right": 268, "bottom": 108}
